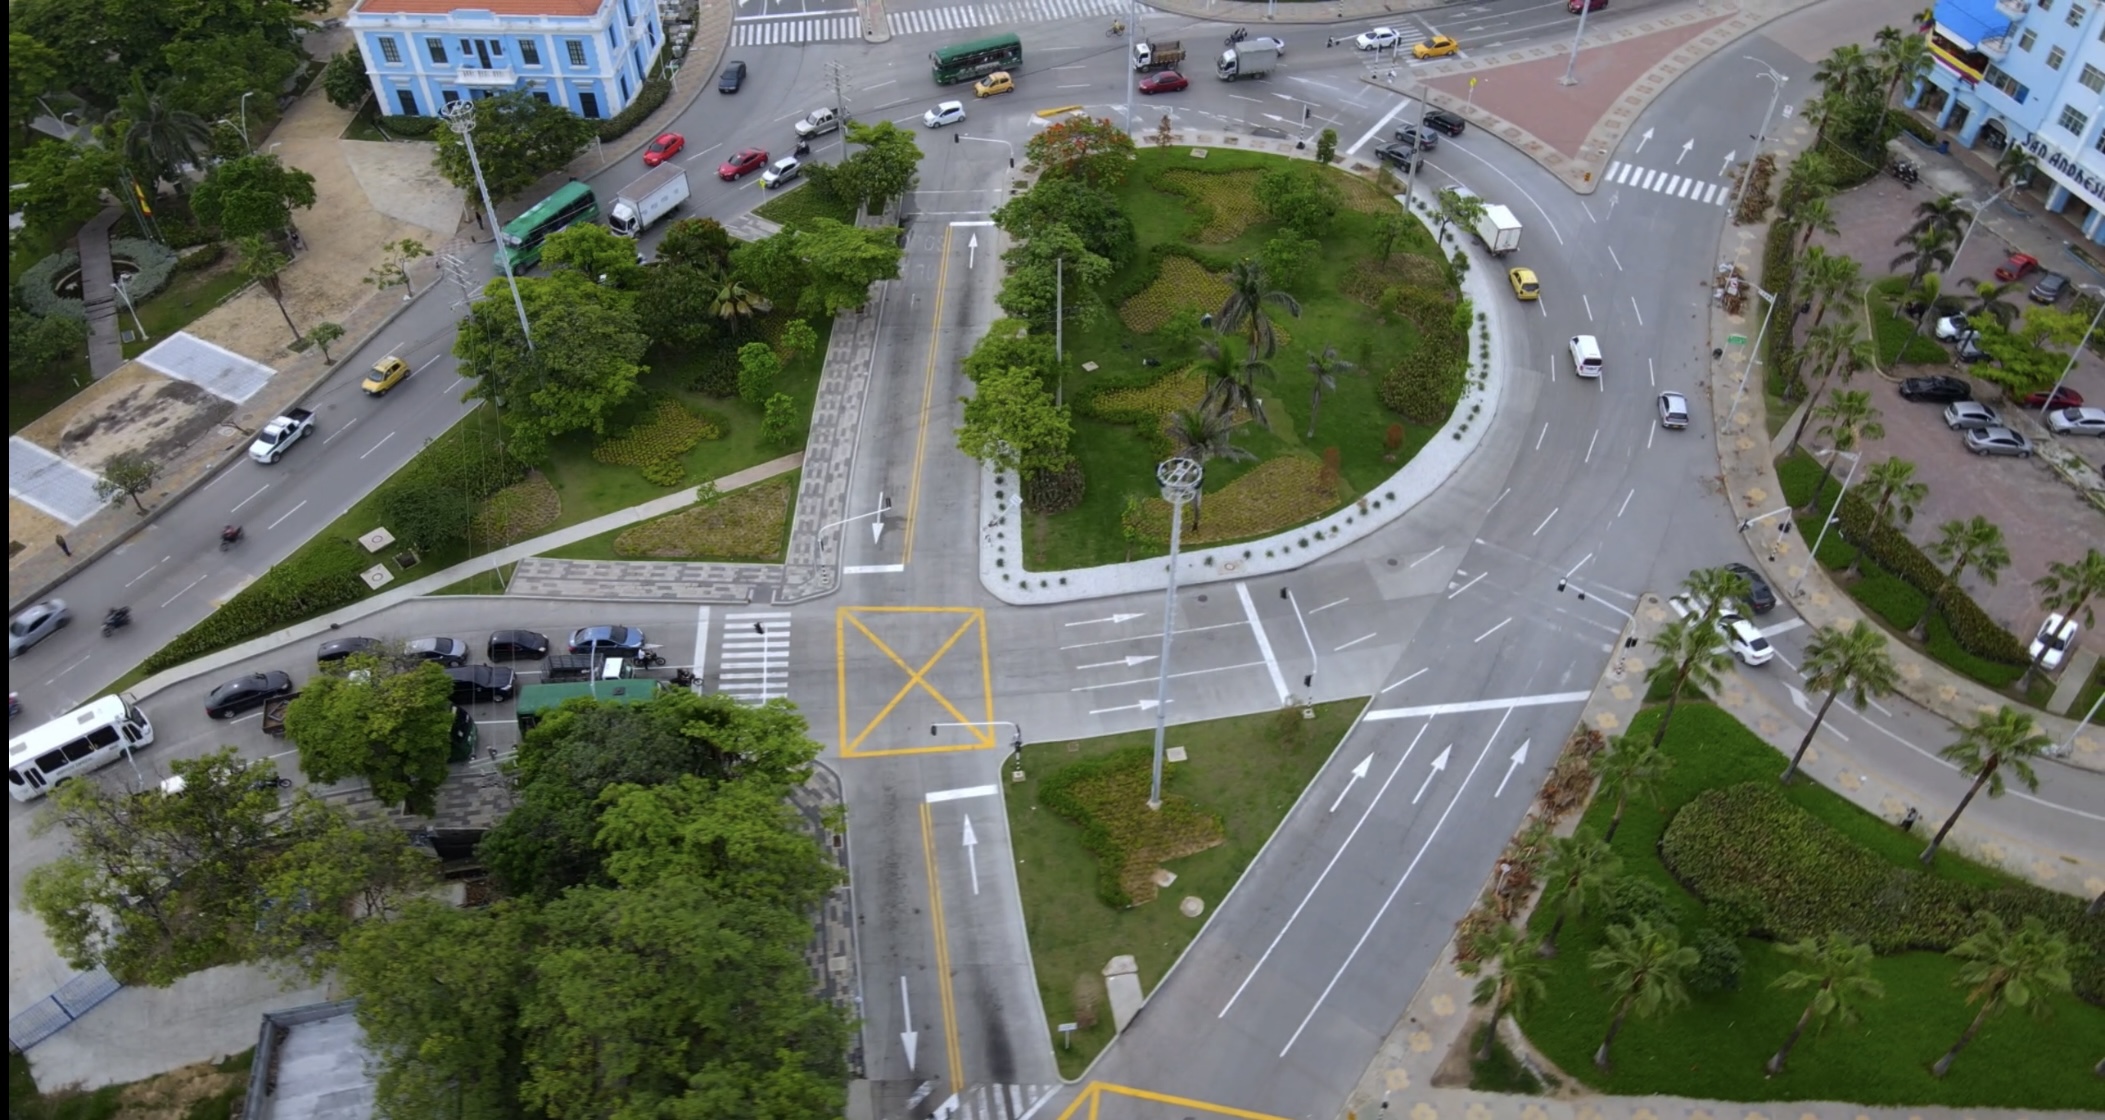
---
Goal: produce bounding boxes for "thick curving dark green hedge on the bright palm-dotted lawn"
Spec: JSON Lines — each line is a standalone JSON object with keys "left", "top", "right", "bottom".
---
{"left": 1659, "top": 781, "right": 2105, "bottom": 1002}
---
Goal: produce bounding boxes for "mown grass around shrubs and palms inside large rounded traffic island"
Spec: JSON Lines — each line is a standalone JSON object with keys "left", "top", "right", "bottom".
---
{"left": 1025, "top": 147, "right": 1455, "bottom": 571}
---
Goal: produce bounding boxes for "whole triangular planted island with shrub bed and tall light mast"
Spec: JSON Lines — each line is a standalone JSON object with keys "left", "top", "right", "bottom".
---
{"left": 1002, "top": 699, "right": 1366, "bottom": 1078}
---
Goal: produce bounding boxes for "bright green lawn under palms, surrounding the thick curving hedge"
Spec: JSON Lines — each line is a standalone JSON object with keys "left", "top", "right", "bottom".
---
{"left": 1522, "top": 703, "right": 2105, "bottom": 1109}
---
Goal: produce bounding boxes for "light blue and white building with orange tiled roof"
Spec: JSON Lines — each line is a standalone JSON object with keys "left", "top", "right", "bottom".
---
{"left": 343, "top": 0, "right": 665, "bottom": 120}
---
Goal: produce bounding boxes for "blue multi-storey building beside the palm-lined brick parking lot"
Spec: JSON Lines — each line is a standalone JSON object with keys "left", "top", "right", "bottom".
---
{"left": 1911, "top": 0, "right": 2105, "bottom": 244}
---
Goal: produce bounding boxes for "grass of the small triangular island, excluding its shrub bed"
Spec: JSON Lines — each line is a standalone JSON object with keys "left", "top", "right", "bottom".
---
{"left": 1002, "top": 699, "right": 1364, "bottom": 1078}
